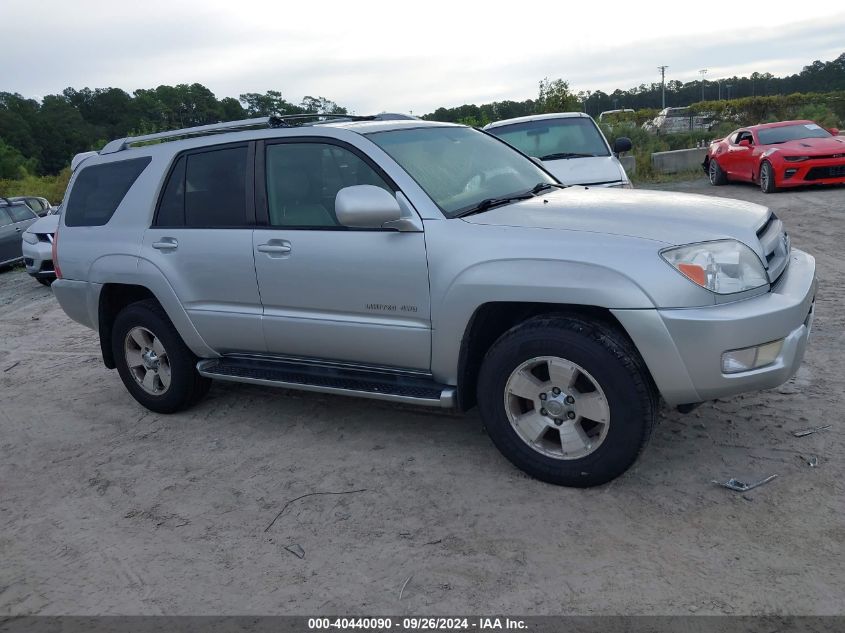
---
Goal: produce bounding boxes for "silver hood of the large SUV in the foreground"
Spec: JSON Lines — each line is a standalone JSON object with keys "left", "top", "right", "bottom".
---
{"left": 464, "top": 187, "right": 769, "bottom": 255}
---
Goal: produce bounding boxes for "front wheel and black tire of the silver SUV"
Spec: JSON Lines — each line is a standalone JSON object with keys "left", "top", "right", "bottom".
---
{"left": 478, "top": 315, "right": 657, "bottom": 488}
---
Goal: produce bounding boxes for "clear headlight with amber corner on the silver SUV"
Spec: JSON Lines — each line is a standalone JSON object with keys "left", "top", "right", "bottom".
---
{"left": 660, "top": 240, "right": 769, "bottom": 295}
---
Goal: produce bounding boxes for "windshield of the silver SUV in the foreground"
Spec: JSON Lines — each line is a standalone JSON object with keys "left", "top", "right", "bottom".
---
{"left": 367, "top": 127, "right": 557, "bottom": 218}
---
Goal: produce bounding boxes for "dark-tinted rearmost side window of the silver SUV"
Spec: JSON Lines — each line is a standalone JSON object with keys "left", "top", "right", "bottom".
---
{"left": 65, "top": 156, "right": 151, "bottom": 226}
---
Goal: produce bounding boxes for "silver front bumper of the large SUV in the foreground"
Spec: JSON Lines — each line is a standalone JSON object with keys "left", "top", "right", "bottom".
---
{"left": 613, "top": 249, "right": 818, "bottom": 405}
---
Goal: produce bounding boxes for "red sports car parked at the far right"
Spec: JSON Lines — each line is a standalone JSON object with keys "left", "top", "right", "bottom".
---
{"left": 703, "top": 121, "right": 845, "bottom": 193}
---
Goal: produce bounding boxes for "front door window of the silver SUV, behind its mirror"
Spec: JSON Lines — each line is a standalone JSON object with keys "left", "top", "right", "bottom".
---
{"left": 265, "top": 143, "right": 393, "bottom": 228}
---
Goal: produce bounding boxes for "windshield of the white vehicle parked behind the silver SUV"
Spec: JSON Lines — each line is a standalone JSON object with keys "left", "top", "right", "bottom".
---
{"left": 487, "top": 117, "right": 610, "bottom": 160}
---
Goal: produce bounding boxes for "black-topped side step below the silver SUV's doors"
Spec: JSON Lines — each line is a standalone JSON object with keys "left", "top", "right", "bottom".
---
{"left": 197, "top": 356, "right": 457, "bottom": 409}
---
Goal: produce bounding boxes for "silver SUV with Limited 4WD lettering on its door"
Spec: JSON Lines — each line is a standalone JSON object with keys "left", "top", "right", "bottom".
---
{"left": 53, "top": 117, "right": 816, "bottom": 486}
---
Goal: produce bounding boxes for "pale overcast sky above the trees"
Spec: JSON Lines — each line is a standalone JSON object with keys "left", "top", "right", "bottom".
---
{"left": 0, "top": 0, "right": 845, "bottom": 114}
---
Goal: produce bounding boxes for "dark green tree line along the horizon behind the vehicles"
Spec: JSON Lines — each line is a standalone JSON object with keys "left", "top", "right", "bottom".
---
{"left": 0, "top": 53, "right": 845, "bottom": 179}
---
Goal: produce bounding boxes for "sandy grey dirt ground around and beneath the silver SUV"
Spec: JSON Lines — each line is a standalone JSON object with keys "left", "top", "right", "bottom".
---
{"left": 0, "top": 180, "right": 845, "bottom": 615}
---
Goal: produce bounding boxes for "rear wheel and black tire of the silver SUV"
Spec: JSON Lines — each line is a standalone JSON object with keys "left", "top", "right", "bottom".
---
{"left": 112, "top": 299, "right": 211, "bottom": 413}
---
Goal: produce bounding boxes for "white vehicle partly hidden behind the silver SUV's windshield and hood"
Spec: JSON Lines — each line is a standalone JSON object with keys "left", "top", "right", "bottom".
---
{"left": 484, "top": 112, "right": 631, "bottom": 189}
